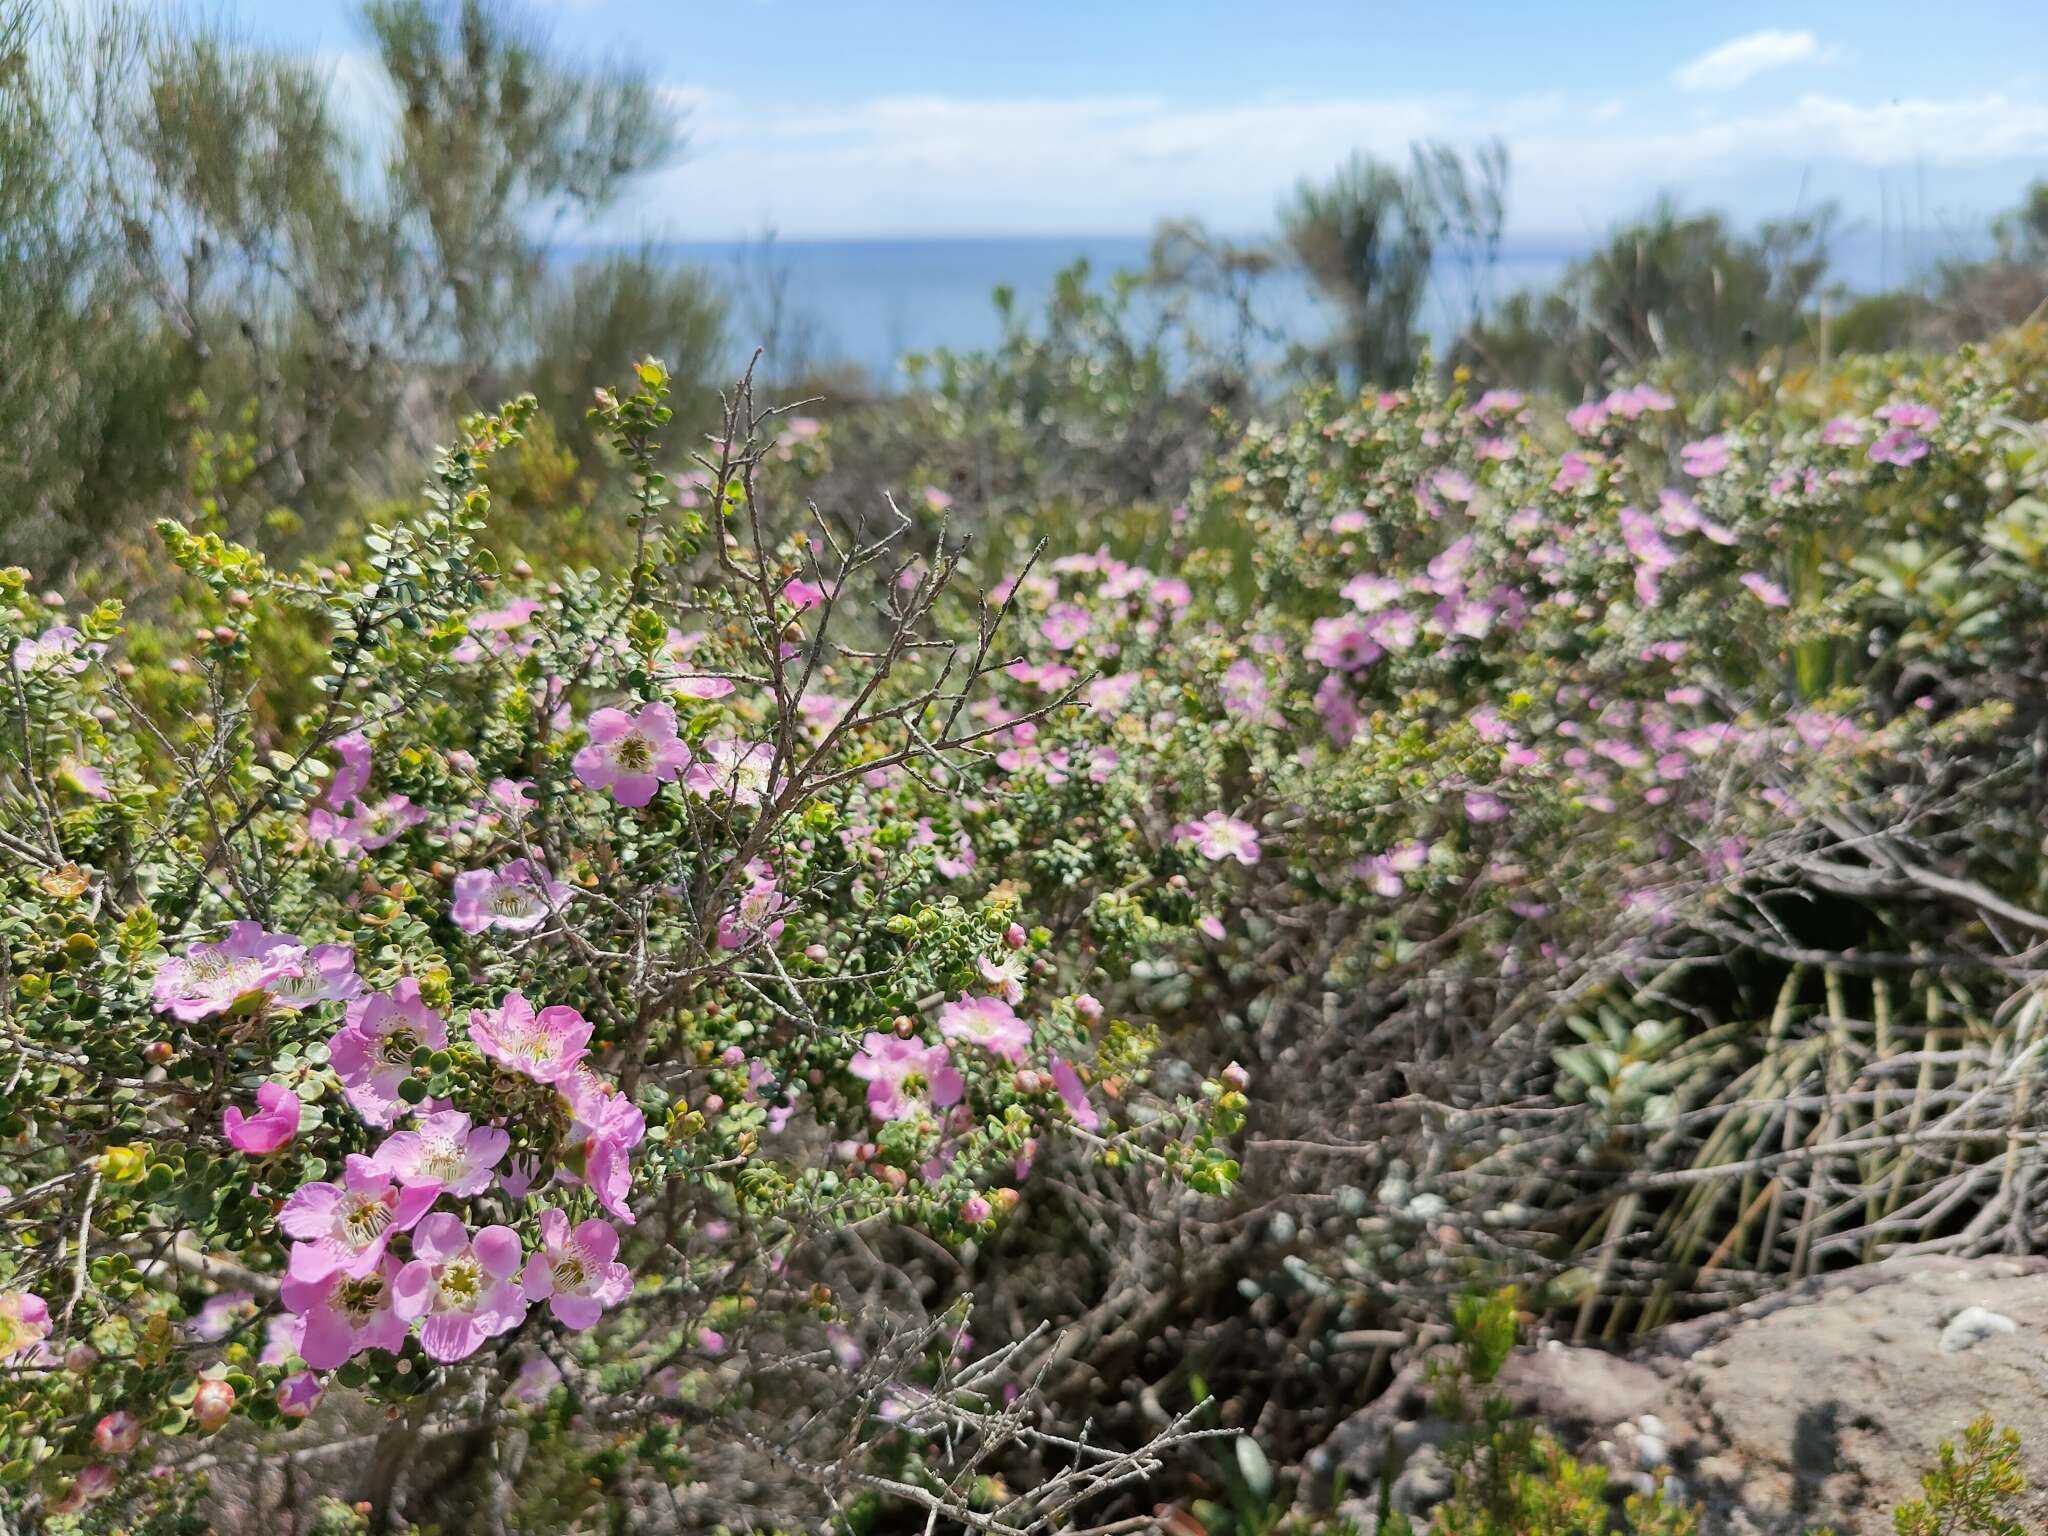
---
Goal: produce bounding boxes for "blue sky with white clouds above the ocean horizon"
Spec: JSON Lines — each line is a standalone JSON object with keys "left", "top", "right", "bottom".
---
{"left": 231, "top": 0, "right": 2048, "bottom": 246}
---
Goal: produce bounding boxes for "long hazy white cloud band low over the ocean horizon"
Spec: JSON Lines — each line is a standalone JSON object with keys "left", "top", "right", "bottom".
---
{"left": 596, "top": 92, "right": 2048, "bottom": 242}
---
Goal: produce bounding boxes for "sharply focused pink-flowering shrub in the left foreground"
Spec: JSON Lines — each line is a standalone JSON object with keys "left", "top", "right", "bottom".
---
{"left": 0, "top": 365, "right": 1231, "bottom": 1511}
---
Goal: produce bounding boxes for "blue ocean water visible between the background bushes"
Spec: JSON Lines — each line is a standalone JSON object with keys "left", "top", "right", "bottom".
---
{"left": 634, "top": 231, "right": 1962, "bottom": 387}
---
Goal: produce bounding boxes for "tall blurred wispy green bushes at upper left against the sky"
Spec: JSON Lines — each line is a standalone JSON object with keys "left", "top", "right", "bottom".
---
{"left": 0, "top": 0, "right": 719, "bottom": 596}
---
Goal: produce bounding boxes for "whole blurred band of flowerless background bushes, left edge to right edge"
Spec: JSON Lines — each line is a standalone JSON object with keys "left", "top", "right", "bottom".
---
{"left": 0, "top": 0, "right": 2048, "bottom": 592}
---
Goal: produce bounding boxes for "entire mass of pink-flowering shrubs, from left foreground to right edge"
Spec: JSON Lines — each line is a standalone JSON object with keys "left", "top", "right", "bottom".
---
{"left": 12, "top": 338, "right": 2048, "bottom": 1530}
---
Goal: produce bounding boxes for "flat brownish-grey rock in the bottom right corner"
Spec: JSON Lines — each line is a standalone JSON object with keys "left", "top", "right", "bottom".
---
{"left": 1303, "top": 1257, "right": 2048, "bottom": 1536}
